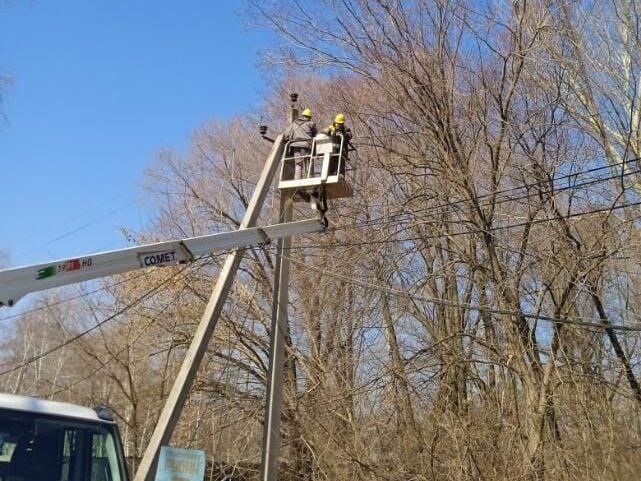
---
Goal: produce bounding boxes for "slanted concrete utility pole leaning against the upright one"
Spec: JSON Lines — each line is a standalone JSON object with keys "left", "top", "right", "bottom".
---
{"left": 134, "top": 130, "right": 291, "bottom": 481}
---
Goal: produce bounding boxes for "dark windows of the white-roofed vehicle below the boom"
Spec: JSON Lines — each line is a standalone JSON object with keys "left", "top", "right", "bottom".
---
{"left": 0, "top": 409, "right": 126, "bottom": 481}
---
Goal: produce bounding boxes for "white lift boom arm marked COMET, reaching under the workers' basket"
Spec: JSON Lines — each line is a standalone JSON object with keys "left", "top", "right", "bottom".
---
{"left": 0, "top": 219, "right": 324, "bottom": 306}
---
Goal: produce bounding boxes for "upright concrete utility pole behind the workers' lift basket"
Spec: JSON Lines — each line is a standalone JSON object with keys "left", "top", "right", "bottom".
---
{"left": 260, "top": 93, "right": 298, "bottom": 481}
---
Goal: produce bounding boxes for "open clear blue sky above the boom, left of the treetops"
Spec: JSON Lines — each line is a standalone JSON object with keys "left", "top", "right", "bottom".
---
{"left": 0, "top": 0, "right": 267, "bottom": 266}
